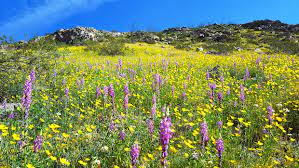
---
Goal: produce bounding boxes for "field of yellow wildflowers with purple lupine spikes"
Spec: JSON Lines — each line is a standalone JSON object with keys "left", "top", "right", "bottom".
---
{"left": 0, "top": 43, "right": 299, "bottom": 168}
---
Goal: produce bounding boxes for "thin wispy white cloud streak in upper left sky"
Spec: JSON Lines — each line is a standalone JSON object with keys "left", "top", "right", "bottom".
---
{"left": 0, "top": 0, "right": 111, "bottom": 39}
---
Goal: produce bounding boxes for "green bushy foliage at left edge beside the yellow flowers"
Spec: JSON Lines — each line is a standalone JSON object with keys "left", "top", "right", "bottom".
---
{"left": 0, "top": 46, "right": 61, "bottom": 102}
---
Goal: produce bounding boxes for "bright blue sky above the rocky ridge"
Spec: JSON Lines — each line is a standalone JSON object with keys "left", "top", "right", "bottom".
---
{"left": 0, "top": 0, "right": 299, "bottom": 40}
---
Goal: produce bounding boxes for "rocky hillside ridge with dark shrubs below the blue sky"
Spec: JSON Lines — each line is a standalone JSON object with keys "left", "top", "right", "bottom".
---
{"left": 2, "top": 20, "right": 299, "bottom": 54}
